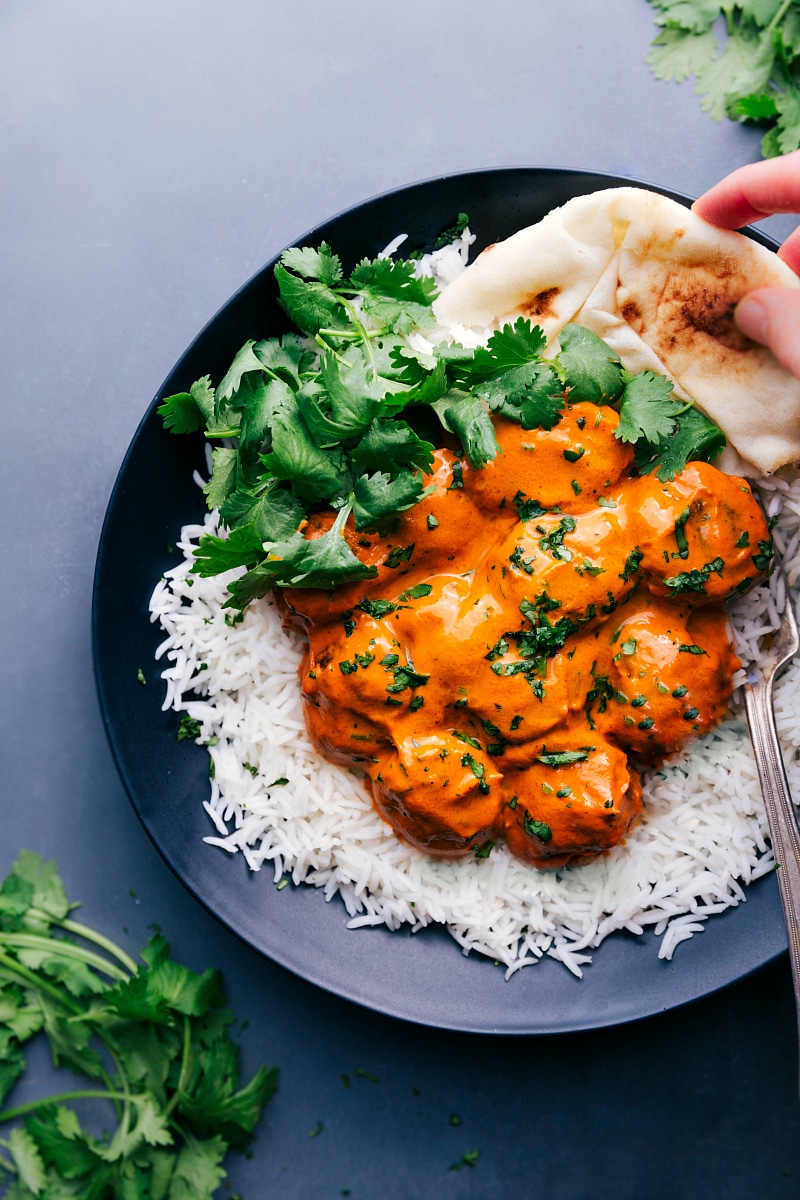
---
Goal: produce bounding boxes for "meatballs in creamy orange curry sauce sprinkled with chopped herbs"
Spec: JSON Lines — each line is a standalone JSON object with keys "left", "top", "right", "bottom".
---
{"left": 282, "top": 403, "right": 769, "bottom": 866}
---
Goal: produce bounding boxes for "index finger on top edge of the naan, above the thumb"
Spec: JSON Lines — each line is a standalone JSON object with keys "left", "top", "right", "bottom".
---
{"left": 692, "top": 150, "right": 800, "bottom": 229}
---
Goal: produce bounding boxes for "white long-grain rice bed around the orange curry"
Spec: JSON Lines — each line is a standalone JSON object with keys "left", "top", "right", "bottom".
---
{"left": 150, "top": 230, "right": 800, "bottom": 978}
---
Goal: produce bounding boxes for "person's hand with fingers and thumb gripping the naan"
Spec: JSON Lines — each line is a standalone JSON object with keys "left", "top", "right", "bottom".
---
{"left": 692, "top": 150, "right": 800, "bottom": 378}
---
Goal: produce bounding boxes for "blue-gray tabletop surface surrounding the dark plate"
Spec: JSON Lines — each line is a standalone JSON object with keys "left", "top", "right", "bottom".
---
{"left": 0, "top": 0, "right": 800, "bottom": 1200}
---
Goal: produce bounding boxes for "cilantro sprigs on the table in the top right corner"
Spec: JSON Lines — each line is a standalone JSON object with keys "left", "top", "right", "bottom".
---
{"left": 648, "top": 0, "right": 800, "bottom": 158}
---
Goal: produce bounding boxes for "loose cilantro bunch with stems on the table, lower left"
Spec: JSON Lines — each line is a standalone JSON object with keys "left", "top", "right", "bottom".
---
{"left": 0, "top": 851, "right": 277, "bottom": 1200}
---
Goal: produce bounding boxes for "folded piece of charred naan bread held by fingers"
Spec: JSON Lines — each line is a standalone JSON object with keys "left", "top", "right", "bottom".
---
{"left": 434, "top": 187, "right": 800, "bottom": 474}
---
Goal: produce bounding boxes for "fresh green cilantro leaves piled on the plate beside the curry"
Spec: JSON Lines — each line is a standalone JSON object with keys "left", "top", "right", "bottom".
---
{"left": 158, "top": 236, "right": 724, "bottom": 610}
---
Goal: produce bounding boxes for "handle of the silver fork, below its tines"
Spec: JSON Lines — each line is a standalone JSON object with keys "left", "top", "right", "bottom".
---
{"left": 745, "top": 679, "right": 800, "bottom": 1090}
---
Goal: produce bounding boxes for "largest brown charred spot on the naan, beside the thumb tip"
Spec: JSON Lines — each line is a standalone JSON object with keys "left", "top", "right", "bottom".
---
{"left": 621, "top": 260, "right": 763, "bottom": 361}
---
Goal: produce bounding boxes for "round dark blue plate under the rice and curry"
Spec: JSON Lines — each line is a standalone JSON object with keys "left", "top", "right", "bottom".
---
{"left": 92, "top": 168, "right": 787, "bottom": 1033}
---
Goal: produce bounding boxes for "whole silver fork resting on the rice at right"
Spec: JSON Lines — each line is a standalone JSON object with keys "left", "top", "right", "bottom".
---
{"left": 745, "top": 558, "right": 800, "bottom": 1091}
